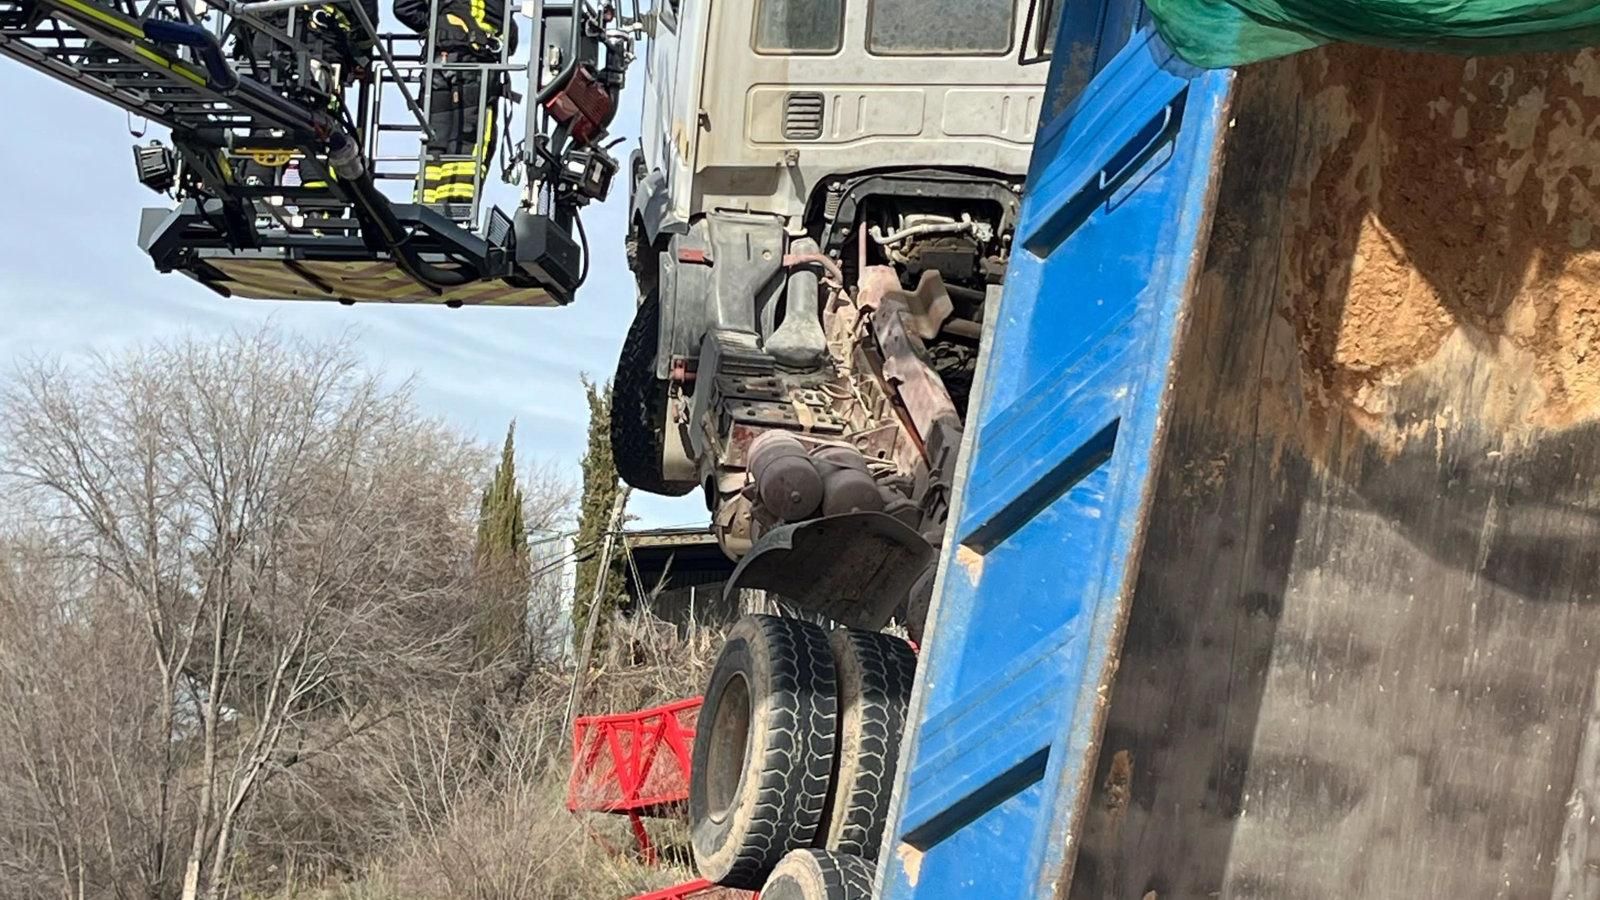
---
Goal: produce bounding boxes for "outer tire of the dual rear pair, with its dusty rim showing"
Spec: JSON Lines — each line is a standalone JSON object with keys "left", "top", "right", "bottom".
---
{"left": 690, "top": 615, "right": 838, "bottom": 890}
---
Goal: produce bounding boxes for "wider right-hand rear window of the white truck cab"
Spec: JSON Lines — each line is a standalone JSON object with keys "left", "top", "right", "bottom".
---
{"left": 867, "top": 0, "right": 1016, "bottom": 56}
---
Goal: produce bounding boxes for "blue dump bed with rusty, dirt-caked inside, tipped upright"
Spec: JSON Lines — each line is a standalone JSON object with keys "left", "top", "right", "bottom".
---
{"left": 880, "top": 0, "right": 1600, "bottom": 900}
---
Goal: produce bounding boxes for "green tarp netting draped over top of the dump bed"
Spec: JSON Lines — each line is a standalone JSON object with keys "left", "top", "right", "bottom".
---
{"left": 1146, "top": 0, "right": 1600, "bottom": 69}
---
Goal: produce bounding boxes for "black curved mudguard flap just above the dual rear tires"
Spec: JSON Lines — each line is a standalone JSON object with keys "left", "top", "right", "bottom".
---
{"left": 725, "top": 512, "right": 938, "bottom": 631}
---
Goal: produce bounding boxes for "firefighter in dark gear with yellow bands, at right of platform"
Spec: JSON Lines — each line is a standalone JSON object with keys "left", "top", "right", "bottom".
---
{"left": 394, "top": 0, "right": 517, "bottom": 203}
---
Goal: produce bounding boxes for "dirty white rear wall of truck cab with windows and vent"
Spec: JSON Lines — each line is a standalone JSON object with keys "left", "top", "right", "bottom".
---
{"left": 634, "top": 0, "right": 1051, "bottom": 243}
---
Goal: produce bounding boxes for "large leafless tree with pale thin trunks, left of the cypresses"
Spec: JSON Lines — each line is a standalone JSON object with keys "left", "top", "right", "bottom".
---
{"left": 0, "top": 331, "right": 483, "bottom": 900}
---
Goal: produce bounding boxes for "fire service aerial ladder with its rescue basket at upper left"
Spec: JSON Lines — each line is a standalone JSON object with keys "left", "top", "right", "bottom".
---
{"left": 0, "top": 0, "right": 632, "bottom": 307}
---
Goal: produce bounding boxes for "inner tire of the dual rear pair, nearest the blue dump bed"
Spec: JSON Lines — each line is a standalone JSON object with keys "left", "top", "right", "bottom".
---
{"left": 818, "top": 628, "right": 917, "bottom": 860}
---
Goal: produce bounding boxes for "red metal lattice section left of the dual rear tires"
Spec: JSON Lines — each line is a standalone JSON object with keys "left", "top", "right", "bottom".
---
{"left": 566, "top": 697, "right": 701, "bottom": 863}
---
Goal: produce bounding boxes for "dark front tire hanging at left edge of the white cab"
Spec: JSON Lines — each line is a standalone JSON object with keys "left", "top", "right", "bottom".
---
{"left": 611, "top": 293, "right": 698, "bottom": 496}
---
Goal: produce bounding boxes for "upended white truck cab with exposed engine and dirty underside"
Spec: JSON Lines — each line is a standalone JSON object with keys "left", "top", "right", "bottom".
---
{"left": 613, "top": 0, "right": 1054, "bottom": 628}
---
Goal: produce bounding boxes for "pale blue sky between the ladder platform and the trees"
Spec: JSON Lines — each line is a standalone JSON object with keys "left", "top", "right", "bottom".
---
{"left": 0, "top": 38, "right": 706, "bottom": 525}
